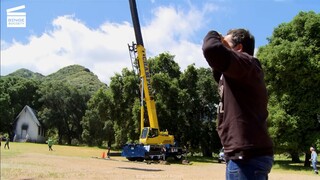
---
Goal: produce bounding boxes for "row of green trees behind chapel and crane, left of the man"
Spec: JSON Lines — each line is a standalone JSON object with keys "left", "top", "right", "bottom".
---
{"left": 1, "top": 53, "right": 221, "bottom": 156}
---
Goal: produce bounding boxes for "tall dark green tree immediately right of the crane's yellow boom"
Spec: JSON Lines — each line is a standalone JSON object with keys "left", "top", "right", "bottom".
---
{"left": 149, "top": 53, "right": 181, "bottom": 144}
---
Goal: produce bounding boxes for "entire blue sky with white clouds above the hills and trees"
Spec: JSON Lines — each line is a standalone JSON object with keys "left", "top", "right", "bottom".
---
{"left": 1, "top": 0, "right": 320, "bottom": 83}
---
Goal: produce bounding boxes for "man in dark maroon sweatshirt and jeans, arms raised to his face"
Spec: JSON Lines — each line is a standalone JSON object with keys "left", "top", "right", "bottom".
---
{"left": 202, "top": 29, "right": 273, "bottom": 180}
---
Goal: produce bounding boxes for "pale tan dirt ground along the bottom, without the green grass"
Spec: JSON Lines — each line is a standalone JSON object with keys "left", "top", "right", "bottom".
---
{"left": 1, "top": 153, "right": 320, "bottom": 180}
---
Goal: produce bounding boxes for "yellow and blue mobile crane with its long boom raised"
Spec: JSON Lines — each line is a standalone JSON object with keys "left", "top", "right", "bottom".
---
{"left": 121, "top": 0, "right": 185, "bottom": 161}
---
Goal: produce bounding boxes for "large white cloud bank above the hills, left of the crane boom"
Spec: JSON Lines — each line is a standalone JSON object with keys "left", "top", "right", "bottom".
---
{"left": 1, "top": 16, "right": 133, "bottom": 82}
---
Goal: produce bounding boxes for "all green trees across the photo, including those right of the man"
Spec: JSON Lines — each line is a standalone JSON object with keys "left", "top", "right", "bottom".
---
{"left": 0, "top": 11, "right": 320, "bottom": 163}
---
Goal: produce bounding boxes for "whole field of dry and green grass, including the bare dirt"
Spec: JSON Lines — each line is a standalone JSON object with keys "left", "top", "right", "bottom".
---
{"left": 1, "top": 143, "right": 320, "bottom": 180}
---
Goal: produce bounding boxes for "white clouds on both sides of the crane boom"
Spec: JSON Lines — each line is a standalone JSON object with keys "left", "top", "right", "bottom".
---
{"left": 1, "top": 2, "right": 220, "bottom": 83}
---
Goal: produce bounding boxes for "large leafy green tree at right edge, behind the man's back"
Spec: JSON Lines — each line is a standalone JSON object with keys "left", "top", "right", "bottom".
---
{"left": 257, "top": 11, "right": 320, "bottom": 165}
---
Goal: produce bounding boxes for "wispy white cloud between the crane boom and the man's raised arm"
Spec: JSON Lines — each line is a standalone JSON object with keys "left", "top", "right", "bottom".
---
{"left": 142, "top": 4, "right": 218, "bottom": 70}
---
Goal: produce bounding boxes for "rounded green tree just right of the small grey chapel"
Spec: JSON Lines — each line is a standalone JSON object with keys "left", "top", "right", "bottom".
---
{"left": 38, "top": 81, "right": 90, "bottom": 144}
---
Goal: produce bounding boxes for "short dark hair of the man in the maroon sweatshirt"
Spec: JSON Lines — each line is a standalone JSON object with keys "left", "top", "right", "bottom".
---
{"left": 227, "top": 29, "right": 255, "bottom": 56}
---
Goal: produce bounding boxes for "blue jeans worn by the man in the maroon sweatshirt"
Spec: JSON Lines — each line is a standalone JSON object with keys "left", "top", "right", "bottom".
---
{"left": 226, "top": 156, "right": 273, "bottom": 180}
